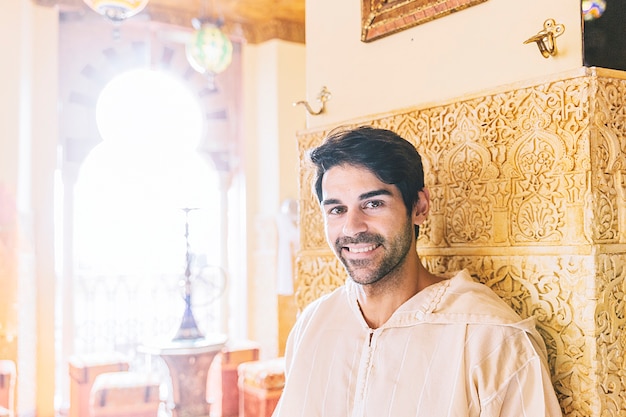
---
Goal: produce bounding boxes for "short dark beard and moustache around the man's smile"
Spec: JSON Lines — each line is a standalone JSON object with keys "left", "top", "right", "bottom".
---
{"left": 334, "top": 220, "right": 414, "bottom": 285}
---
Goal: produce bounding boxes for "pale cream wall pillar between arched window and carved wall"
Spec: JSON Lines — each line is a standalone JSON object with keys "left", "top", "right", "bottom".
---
{"left": 243, "top": 40, "right": 305, "bottom": 358}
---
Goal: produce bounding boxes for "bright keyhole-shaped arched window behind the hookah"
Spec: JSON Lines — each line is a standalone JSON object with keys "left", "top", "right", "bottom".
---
{"left": 73, "top": 70, "right": 225, "bottom": 357}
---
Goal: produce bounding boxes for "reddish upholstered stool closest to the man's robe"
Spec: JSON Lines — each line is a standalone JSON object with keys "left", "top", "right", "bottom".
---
{"left": 238, "top": 358, "right": 285, "bottom": 417}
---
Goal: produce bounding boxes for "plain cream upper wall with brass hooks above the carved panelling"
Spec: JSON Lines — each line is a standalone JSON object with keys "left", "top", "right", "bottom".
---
{"left": 306, "top": 0, "right": 582, "bottom": 127}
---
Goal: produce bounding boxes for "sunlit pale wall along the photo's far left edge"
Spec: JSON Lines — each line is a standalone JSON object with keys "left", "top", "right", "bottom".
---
{"left": 0, "top": 0, "right": 58, "bottom": 417}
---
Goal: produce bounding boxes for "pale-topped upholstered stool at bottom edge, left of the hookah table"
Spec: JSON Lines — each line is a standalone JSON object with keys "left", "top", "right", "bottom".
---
{"left": 89, "top": 371, "right": 161, "bottom": 417}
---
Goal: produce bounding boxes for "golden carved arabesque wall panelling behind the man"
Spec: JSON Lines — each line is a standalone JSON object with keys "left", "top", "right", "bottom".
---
{"left": 296, "top": 68, "right": 626, "bottom": 417}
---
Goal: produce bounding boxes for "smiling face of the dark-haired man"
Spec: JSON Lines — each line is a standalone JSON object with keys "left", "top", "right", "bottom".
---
{"left": 321, "top": 165, "right": 415, "bottom": 285}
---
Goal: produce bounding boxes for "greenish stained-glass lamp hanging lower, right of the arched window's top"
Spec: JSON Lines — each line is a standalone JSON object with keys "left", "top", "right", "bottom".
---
{"left": 186, "top": 19, "right": 233, "bottom": 89}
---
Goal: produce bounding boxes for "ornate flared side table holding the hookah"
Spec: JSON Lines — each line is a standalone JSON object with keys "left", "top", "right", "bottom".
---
{"left": 140, "top": 335, "right": 227, "bottom": 417}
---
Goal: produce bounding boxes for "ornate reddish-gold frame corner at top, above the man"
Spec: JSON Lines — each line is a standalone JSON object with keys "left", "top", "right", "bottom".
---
{"left": 361, "top": 0, "right": 487, "bottom": 42}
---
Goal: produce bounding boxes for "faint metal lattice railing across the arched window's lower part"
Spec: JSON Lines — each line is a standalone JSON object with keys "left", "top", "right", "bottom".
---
{"left": 74, "top": 272, "right": 223, "bottom": 357}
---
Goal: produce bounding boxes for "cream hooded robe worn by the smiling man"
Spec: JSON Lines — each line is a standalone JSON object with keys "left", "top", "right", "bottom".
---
{"left": 273, "top": 271, "right": 562, "bottom": 417}
